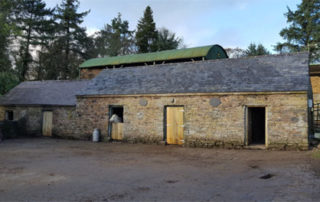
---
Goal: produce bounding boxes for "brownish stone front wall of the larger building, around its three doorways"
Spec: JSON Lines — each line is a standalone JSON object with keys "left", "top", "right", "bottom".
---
{"left": 73, "top": 94, "right": 308, "bottom": 149}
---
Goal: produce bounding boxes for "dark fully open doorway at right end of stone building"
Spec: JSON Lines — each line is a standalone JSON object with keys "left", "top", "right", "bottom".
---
{"left": 248, "top": 107, "right": 266, "bottom": 145}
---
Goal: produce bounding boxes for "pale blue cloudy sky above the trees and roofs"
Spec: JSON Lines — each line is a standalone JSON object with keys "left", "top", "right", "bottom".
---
{"left": 45, "top": 0, "right": 301, "bottom": 51}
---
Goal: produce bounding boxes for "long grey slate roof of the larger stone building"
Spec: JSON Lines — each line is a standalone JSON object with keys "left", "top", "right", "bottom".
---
{"left": 78, "top": 53, "right": 309, "bottom": 96}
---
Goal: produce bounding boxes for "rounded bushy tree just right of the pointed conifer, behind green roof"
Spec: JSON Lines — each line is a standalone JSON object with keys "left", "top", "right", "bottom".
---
{"left": 157, "top": 28, "right": 182, "bottom": 51}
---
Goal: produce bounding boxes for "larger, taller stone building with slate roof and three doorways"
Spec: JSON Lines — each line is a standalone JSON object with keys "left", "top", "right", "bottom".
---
{"left": 74, "top": 53, "right": 311, "bottom": 149}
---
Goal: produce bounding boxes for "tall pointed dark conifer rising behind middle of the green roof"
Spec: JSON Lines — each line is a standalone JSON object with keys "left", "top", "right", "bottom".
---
{"left": 136, "top": 6, "right": 158, "bottom": 53}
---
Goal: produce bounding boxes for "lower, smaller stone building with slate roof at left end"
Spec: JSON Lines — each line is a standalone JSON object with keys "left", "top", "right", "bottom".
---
{"left": 0, "top": 80, "right": 87, "bottom": 137}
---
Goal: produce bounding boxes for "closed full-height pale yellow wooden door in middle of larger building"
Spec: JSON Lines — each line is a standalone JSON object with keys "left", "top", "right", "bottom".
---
{"left": 167, "top": 107, "right": 184, "bottom": 145}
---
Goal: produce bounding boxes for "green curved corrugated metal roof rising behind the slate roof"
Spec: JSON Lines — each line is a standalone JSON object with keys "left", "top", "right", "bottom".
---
{"left": 80, "top": 45, "right": 228, "bottom": 68}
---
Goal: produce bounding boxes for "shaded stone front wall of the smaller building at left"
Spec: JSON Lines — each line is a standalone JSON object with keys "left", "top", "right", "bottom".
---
{"left": 0, "top": 106, "right": 76, "bottom": 137}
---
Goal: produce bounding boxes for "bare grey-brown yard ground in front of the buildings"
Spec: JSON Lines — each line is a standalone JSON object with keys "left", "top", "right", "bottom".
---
{"left": 0, "top": 138, "right": 320, "bottom": 201}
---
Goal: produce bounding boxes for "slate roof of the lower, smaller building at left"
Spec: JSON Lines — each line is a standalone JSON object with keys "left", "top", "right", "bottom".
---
{"left": 0, "top": 80, "right": 88, "bottom": 106}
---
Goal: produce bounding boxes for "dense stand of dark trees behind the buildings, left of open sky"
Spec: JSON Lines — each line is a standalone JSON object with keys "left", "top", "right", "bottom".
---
{"left": 0, "top": 0, "right": 182, "bottom": 91}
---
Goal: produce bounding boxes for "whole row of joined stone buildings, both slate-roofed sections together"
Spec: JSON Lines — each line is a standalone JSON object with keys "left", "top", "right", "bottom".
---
{"left": 0, "top": 49, "right": 312, "bottom": 149}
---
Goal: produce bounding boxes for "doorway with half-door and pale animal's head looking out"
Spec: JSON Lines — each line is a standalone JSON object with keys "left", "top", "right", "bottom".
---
{"left": 108, "top": 106, "right": 124, "bottom": 140}
